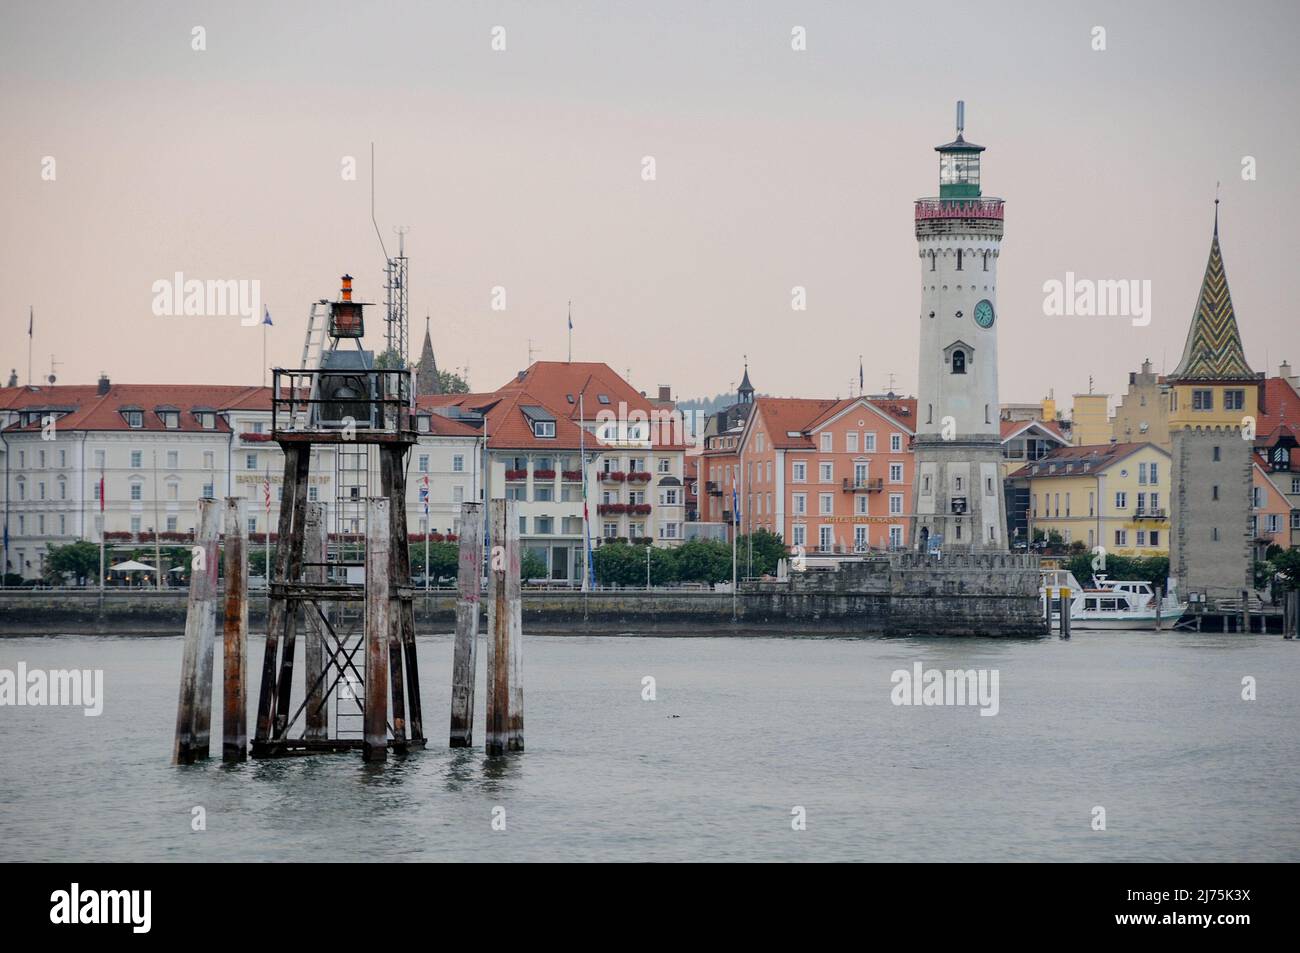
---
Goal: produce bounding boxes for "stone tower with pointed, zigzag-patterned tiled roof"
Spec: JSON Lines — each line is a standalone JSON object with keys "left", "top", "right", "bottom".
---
{"left": 1167, "top": 199, "right": 1262, "bottom": 599}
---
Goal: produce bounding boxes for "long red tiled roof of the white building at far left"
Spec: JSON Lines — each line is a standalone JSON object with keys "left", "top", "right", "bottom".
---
{"left": 0, "top": 384, "right": 270, "bottom": 433}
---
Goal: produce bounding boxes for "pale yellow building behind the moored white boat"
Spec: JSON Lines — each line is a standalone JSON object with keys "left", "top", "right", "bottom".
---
{"left": 1010, "top": 443, "right": 1171, "bottom": 556}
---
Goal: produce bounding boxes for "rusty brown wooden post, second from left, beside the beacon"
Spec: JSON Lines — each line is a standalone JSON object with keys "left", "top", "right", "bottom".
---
{"left": 221, "top": 497, "right": 248, "bottom": 761}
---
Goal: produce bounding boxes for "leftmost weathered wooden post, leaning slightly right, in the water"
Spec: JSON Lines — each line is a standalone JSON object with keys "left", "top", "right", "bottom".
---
{"left": 172, "top": 499, "right": 217, "bottom": 764}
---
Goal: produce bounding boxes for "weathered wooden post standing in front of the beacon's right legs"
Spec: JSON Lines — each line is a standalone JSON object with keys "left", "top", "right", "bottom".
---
{"left": 361, "top": 497, "right": 391, "bottom": 761}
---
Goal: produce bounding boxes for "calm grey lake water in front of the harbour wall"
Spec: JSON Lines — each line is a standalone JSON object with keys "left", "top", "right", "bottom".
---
{"left": 0, "top": 632, "right": 1300, "bottom": 861}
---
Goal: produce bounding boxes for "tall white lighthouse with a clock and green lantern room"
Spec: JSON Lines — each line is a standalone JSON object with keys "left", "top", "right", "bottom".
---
{"left": 911, "top": 103, "right": 1006, "bottom": 553}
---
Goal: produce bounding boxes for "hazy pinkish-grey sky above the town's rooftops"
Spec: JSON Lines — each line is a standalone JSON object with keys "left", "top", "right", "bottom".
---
{"left": 0, "top": 0, "right": 1300, "bottom": 400}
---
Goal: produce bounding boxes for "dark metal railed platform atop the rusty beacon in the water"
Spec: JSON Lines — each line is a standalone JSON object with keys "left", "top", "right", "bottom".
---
{"left": 270, "top": 368, "right": 416, "bottom": 443}
